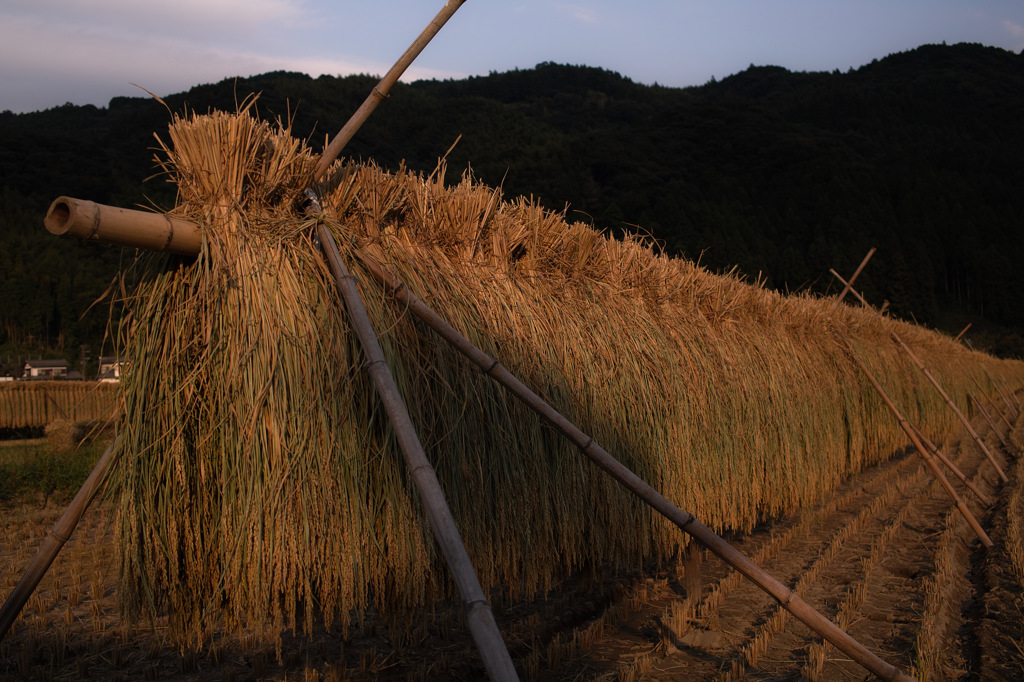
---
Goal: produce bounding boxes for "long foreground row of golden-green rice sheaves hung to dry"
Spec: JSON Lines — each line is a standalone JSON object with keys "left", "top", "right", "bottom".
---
{"left": 113, "top": 111, "right": 1024, "bottom": 639}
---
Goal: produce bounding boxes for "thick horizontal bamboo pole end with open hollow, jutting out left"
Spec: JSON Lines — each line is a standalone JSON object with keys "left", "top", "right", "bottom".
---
{"left": 43, "top": 197, "right": 203, "bottom": 255}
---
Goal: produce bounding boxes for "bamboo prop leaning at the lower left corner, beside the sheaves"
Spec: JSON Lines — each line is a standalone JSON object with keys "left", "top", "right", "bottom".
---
{"left": 0, "top": 439, "right": 118, "bottom": 639}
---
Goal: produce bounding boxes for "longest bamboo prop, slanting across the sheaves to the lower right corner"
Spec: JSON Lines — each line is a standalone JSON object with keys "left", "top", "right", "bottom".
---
{"left": 356, "top": 251, "right": 913, "bottom": 682}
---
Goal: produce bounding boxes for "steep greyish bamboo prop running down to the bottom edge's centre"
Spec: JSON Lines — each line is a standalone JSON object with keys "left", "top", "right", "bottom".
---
{"left": 317, "top": 225, "right": 518, "bottom": 680}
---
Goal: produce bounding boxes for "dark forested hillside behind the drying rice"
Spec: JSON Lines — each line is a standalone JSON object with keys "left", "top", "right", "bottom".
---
{"left": 0, "top": 45, "right": 1024, "bottom": 374}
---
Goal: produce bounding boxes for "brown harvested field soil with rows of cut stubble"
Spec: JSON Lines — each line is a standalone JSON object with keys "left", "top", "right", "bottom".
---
{"left": 0, "top": 405, "right": 1024, "bottom": 680}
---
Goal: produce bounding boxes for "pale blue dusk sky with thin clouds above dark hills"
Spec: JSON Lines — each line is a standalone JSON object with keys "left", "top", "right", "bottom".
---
{"left": 0, "top": 0, "right": 1024, "bottom": 113}
